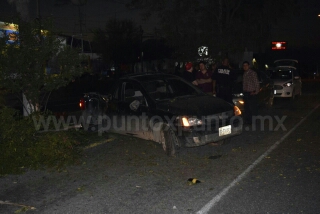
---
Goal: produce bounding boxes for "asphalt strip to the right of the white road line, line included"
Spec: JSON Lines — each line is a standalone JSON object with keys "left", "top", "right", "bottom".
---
{"left": 205, "top": 98, "right": 320, "bottom": 213}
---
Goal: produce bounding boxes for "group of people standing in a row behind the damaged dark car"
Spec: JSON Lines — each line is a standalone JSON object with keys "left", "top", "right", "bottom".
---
{"left": 183, "top": 58, "right": 260, "bottom": 124}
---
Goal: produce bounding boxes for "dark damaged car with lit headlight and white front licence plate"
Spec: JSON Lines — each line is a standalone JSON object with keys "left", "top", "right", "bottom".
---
{"left": 80, "top": 73, "right": 242, "bottom": 156}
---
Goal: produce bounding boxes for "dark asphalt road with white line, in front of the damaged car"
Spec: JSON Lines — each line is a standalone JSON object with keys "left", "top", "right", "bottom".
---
{"left": 0, "top": 79, "right": 320, "bottom": 214}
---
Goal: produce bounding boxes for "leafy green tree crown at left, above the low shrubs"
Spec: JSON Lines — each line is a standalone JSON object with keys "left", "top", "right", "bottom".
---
{"left": 0, "top": 16, "right": 85, "bottom": 112}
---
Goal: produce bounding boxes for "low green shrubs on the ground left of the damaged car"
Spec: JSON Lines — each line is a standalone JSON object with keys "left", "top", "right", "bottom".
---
{"left": 0, "top": 108, "right": 81, "bottom": 176}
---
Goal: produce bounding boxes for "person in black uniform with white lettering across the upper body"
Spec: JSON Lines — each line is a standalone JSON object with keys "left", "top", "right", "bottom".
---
{"left": 212, "top": 58, "right": 234, "bottom": 103}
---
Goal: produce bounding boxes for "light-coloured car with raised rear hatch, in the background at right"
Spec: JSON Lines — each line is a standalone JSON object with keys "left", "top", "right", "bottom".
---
{"left": 271, "top": 59, "right": 302, "bottom": 99}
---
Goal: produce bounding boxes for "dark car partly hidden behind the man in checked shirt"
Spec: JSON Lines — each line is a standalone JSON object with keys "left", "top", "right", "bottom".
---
{"left": 233, "top": 70, "right": 274, "bottom": 111}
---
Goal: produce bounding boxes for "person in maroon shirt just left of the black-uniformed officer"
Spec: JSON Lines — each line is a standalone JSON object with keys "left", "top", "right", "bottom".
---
{"left": 196, "top": 61, "right": 213, "bottom": 95}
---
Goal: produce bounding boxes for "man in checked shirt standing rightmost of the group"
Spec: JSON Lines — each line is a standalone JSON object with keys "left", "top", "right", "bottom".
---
{"left": 242, "top": 61, "right": 260, "bottom": 125}
